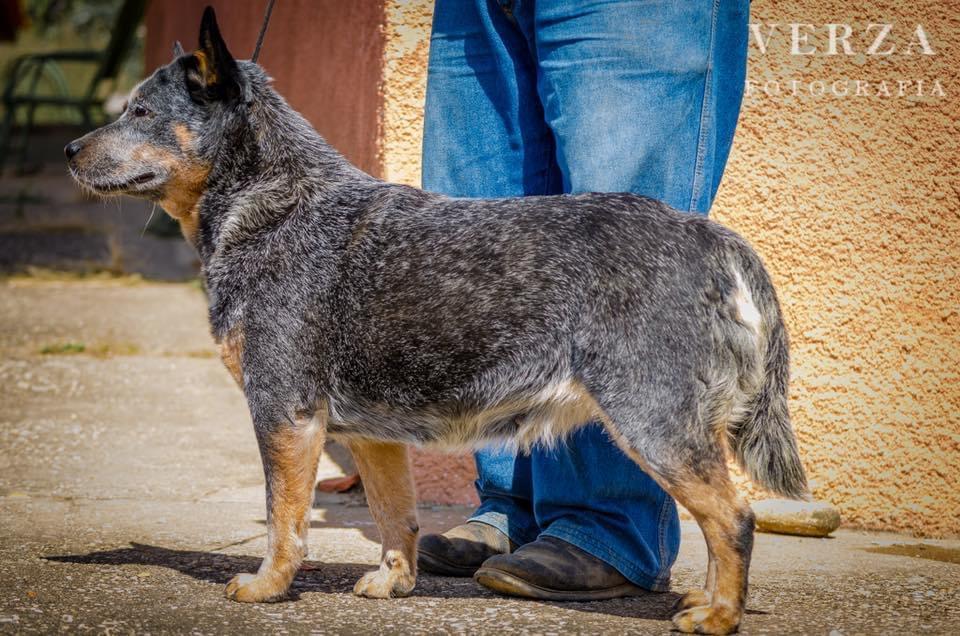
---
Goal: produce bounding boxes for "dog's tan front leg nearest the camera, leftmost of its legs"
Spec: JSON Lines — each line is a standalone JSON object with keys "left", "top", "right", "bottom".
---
{"left": 226, "top": 414, "right": 325, "bottom": 603}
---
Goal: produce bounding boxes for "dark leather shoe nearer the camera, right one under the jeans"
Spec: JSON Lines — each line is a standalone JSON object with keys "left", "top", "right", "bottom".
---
{"left": 473, "top": 537, "right": 648, "bottom": 601}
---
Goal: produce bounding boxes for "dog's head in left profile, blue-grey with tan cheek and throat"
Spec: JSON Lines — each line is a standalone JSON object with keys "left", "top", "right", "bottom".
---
{"left": 64, "top": 7, "right": 250, "bottom": 236}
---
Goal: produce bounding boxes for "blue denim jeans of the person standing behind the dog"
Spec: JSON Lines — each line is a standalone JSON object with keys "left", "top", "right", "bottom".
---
{"left": 423, "top": 0, "right": 749, "bottom": 590}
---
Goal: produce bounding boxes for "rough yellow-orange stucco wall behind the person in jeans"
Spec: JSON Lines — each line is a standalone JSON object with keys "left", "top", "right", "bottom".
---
{"left": 380, "top": 0, "right": 960, "bottom": 536}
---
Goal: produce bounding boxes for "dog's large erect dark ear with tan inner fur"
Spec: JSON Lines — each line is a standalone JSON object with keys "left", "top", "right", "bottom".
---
{"left": 185, "top": 6, "right": 245, "bottom": 102}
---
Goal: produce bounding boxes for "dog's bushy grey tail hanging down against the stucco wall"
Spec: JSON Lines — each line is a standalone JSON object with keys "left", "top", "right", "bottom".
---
{"left": 731, "top": 247, "right": 809, "bottom": 499}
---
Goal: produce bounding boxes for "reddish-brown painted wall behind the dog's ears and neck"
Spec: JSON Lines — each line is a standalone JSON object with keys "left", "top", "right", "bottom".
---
{"left": 146, "top": 0, "right": 383, "bottom": 176}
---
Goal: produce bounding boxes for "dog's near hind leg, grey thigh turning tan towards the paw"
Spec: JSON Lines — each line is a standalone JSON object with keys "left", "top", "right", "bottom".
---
{"left": 607, "top": 409, "right": 754, "bottom": 634}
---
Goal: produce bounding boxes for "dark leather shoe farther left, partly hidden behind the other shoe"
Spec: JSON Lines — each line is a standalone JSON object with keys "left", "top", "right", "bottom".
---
{"left": 417, "top": 521, "right": 514, "bottom": 576}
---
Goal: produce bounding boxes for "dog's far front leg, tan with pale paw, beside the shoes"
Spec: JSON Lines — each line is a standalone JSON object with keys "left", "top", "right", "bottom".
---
{"left": 349, "top": 440, "right": 419, "bottom": 598}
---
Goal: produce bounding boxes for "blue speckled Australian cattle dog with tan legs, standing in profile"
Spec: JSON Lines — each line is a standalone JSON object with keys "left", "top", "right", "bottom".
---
{"left": 65, "top": 8, "right": 807, "bottom": 634}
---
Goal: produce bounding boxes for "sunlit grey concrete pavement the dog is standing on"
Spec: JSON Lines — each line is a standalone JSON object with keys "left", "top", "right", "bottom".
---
{"left": 0, "top": 277, "right": 960, "bottom": 635}
